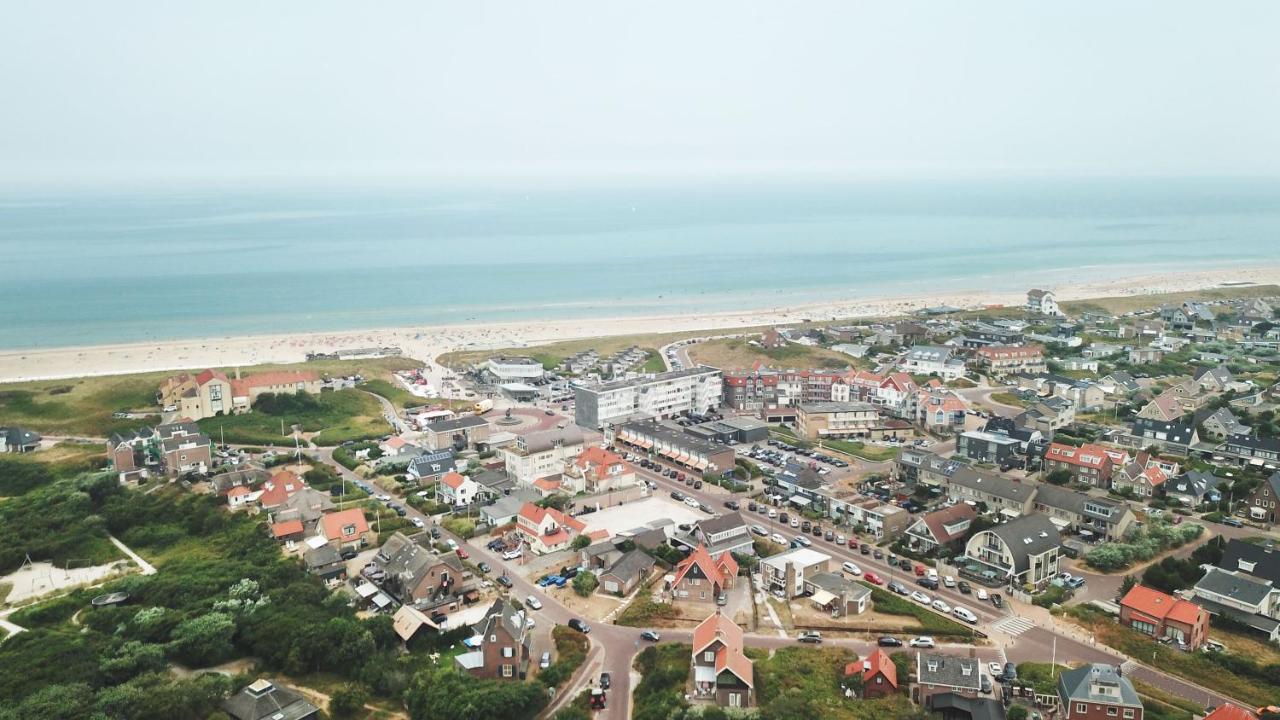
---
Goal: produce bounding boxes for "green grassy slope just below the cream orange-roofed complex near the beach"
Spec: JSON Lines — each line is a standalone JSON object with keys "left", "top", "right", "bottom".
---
{"left": 200, "top": 389, "right": 390, "bottom": 446}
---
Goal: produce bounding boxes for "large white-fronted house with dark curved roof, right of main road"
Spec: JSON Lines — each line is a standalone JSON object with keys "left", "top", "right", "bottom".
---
{"left": 965, "top": 514, "right": 1061, "bottom": 587}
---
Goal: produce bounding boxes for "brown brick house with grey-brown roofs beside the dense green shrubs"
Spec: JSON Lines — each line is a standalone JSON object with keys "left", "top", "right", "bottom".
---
{"left": 374, "top": 532, "right": 479, "bottom": 611}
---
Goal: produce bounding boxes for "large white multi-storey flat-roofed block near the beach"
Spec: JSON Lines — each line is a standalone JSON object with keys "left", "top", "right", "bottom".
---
{"left": 573, "top": 366, "right": 722, "bottom": 428}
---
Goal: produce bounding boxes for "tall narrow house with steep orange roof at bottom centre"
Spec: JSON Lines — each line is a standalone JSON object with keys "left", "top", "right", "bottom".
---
{"left": 692, "top": 611, "right": 755, "bottom": 707}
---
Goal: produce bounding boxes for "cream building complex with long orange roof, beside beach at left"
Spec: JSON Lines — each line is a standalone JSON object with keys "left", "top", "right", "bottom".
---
{"left": 156, "top": 369, "right": 324, "bottom": 420}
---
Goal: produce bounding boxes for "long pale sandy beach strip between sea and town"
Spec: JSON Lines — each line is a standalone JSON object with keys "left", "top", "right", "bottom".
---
{"left": 0, "top": 265, "right": 1280, "bottom": 382}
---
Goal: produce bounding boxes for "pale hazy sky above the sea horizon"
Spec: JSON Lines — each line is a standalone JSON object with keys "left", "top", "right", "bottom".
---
{"left": 0, "top": 0, "right": 1280, "bottom": 184}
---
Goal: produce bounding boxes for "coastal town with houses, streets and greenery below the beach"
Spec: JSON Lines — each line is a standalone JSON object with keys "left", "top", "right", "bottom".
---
{"left": 0, "top": 286, "right": 1280, "bottom": 720}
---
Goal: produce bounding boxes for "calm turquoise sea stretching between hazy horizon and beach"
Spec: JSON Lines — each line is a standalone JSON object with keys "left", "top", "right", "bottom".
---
{"left": 0, "top": 179, "right": 1280, "bottom": 348}
